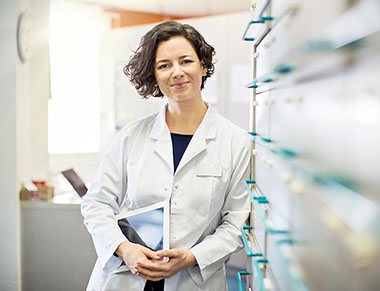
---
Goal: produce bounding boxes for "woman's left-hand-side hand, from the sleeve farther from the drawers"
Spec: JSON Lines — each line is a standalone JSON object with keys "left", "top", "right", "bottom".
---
{"left": 116, "top": 241, "right": 161, "bottom": 274}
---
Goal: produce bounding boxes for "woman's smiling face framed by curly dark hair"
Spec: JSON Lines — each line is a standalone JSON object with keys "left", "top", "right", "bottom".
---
{"left": 154, "top": 36, "right": 207, "bottom": 102}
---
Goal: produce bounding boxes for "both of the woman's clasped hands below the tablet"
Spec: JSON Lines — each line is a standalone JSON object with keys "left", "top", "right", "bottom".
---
{"left": 116, "top": 241, "right": 197, "bottom": 281}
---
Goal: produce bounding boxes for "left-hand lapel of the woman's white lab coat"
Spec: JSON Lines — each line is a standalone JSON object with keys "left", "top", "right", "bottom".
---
{"left": 150, "top": 105, "right": 173, "bottom": 172}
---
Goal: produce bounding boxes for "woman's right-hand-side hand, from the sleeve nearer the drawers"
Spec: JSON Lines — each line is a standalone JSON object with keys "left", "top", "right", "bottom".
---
{"left": 136, "top": 249, "right": 197, "bottom": 281}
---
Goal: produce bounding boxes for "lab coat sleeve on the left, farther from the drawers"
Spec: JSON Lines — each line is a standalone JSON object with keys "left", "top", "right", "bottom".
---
{"left": 81, "top": 132, "right": 128, "bottom": 272}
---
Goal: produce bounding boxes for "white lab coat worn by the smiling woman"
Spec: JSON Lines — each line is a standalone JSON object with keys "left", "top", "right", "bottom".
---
{"left": 81, "top": 105, "right": 251, "bottom": 291}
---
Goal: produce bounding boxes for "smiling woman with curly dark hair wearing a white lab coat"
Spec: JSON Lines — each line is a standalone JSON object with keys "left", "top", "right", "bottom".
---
{"left": 82, "top": 21, "right": 251, "bottom": 291}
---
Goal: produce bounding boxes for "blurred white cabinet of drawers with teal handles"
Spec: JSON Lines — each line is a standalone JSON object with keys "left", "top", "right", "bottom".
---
{"left": 238, "top": 0, "right": 380, "bottom": 291}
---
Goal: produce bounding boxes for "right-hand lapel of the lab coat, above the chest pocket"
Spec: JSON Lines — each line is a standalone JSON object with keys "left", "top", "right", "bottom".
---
{"left": 176, "top": 106, "right": 217, "bottom": 173}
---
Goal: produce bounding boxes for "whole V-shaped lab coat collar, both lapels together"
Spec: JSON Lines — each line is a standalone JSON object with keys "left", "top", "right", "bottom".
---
{"left": 150, "top": 104, "right": 217, "bottom": 173}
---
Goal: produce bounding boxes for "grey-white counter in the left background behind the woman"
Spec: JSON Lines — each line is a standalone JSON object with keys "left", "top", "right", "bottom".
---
{"left": 21, "top": 200, "right": 96, "bottom": 291}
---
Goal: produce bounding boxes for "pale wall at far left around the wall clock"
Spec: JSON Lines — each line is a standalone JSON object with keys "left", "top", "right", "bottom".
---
{"left": 0, "top": 0, "right": 49, "bottom": 290}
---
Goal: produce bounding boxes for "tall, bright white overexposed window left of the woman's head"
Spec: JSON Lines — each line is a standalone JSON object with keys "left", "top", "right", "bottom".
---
{"left": 48, "top": 1, "right": 105, "bottom": 153}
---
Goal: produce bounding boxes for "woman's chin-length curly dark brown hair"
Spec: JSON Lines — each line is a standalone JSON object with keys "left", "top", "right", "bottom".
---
{"left": 123, "top": 21, "right": 215, "bottom": 99}
